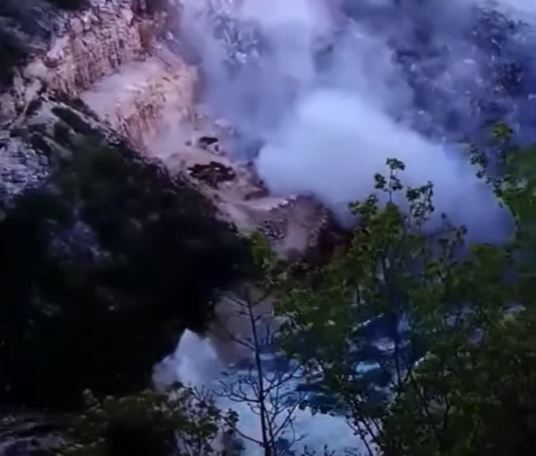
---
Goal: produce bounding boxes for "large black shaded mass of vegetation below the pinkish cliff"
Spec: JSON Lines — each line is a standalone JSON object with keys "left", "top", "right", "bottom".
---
{"left": 0, "top": 134, "right": 248, "bottom": 406}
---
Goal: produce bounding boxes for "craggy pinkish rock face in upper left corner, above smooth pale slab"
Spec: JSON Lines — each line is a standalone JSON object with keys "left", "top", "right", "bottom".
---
{"left": 0, "top": 0, "right": 160, "bottom": 123}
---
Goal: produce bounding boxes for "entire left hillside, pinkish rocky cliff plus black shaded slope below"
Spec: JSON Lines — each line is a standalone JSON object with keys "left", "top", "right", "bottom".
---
{"left": 0, "top": 0, "right": 336, "bottom": 455}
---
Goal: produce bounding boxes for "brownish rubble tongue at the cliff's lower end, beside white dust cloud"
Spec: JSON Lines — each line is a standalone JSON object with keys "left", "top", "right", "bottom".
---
{"left": 160, "top": 132, "right": 332, "bottom": 260}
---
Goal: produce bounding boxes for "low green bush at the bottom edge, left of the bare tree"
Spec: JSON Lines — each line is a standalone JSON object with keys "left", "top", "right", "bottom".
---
{"left": 61, "top": 386, "right": 236, "bottom": 456}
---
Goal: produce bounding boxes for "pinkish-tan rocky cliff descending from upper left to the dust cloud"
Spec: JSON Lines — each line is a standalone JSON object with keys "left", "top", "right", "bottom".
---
{"left": 0, "top": 0, "right": 336, "bottom": 264}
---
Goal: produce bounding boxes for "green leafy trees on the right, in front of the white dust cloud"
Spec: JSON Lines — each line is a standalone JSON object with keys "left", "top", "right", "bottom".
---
{"left": 281, "top": 160, "right": 536, "bottom": 456}
